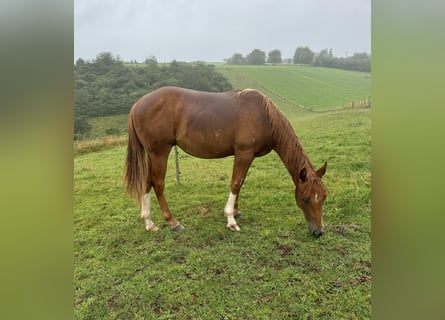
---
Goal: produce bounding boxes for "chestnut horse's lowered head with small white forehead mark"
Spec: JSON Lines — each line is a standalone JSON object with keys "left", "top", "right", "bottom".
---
{"left": 295, "top": 162, "right": 328, "bottom": 238}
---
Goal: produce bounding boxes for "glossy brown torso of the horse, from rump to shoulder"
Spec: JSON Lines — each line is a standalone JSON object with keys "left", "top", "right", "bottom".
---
{"left": 132, "top": 87, "right": 271, "bottom": 158}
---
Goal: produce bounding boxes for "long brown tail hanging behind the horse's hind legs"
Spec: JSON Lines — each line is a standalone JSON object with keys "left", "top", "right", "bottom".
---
{"left": 125, "top": 112, "right": 150, "bottom": 203}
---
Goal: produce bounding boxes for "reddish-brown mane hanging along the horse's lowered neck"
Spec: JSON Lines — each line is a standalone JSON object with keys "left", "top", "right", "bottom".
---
{"left": 253, "top": 93, "right": 313, "bottom": 179}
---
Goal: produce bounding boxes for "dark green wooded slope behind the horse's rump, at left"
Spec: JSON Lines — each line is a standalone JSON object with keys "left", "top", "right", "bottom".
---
{"left": 74, "top": 52, "right": 232, "bottom": 138}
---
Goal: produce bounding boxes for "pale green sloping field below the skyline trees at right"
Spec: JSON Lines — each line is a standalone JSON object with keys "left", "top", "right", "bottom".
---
{"left": 217, "top": 65, "right": 371, "bottom": 110}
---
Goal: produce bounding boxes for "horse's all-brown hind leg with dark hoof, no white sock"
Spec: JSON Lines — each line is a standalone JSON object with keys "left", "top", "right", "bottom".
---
{"left": 150, "top": 153, "right": 184, "bottom": 231}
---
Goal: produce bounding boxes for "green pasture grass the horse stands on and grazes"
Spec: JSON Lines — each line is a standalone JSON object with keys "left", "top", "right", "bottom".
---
{"left": 74, "top": 109, "right": 371, "bottom": 319}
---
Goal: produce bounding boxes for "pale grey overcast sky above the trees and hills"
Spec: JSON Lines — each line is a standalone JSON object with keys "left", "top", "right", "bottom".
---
{"left": 74, "top": 0, "right": 371, "bottom": 62}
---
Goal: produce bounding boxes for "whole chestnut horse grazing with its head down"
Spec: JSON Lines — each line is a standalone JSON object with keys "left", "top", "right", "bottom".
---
{"left": 125, "top": 87, "right": 327, "bottom": 237}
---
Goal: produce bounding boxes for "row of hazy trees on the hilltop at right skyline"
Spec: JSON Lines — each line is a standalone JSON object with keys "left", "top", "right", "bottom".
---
{"left": 226, "top": 46, "right": 371, "bottom": 72}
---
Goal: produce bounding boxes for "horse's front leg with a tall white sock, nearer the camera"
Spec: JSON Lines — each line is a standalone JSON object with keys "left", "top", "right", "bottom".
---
{"left": 224, "top": 155, "right": 254, "bottom": 231}
